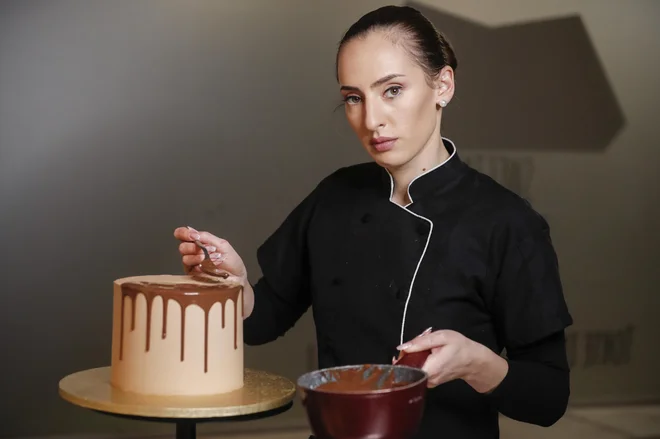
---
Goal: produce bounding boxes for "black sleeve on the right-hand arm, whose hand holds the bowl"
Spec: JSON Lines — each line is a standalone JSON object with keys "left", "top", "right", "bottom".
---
{"left": 489, "top": 212, "right": 573, "bottom": 426}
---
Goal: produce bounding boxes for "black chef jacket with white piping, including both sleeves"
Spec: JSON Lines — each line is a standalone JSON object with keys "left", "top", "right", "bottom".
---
{"left": 244, "top": 138, "right": 572, "bottom": 439}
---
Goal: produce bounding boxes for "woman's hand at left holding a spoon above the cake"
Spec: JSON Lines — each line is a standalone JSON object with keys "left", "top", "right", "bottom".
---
{"left": 174, "top": 226, "right": 247, "bottom": 282}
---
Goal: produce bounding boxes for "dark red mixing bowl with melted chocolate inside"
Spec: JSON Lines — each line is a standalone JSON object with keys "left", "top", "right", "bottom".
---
{"left": 297, "top": 364, "right": 428, "bottom": 439}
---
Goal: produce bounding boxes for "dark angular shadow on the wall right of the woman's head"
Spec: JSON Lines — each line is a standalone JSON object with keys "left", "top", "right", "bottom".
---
{"left": 406, "top": 2, "right": 624, "bottom": 153}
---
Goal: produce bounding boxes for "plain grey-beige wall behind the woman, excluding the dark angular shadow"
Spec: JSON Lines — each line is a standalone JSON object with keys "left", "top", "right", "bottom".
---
{"left": 0, "top": 0, "right": 660, "bottom": 437}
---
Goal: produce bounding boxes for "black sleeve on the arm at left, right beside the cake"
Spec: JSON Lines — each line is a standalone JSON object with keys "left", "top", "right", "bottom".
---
{"left": 243, "top": 185, "right": 320, "bottom": 345}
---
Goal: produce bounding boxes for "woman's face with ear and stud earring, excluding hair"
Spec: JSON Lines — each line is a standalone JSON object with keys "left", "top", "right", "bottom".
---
{"left": 337, "top": 31, "right": 453, "bottom": 169}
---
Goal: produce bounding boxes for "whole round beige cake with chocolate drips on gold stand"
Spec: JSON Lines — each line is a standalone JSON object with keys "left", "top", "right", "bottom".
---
{"left": 111, "top": 275, "right": 244, "bottom": 395}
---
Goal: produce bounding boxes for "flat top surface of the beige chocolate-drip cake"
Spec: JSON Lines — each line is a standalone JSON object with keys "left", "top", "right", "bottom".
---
{"left": 115, "top": 273, "right": 241, "bottom": 292}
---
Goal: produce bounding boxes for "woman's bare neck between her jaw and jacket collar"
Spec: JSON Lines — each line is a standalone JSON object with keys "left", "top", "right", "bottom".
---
{"left": 389, "top": 133, "right": 449, "bottom": 206}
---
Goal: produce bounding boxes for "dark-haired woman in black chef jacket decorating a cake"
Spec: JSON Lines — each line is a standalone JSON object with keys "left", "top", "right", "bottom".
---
{"left": 175, "top": 6, "right": 572, "bottom": 439}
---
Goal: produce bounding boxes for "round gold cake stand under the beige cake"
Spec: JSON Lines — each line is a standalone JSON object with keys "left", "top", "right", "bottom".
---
{"left": 59, "top": 367, "right": 296, "bottom": 439}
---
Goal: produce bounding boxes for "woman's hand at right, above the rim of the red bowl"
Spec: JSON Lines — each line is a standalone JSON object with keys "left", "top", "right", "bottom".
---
{"left": 398, "top": 330, "right": 508, "bottom": 392}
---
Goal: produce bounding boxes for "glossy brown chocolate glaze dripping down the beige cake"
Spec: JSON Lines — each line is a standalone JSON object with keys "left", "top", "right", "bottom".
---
{"left": 119, "top": 276, "right": 245, "bottom": 372}
